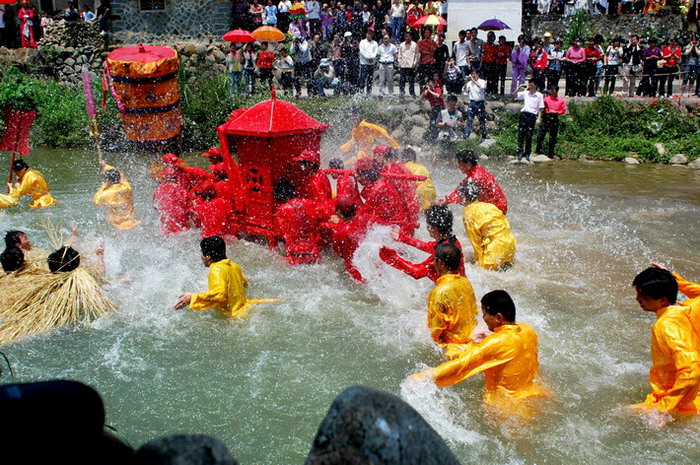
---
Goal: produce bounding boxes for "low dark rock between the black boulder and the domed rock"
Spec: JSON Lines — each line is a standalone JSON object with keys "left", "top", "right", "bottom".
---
{"left": 135, "top": 435, "right": 238, "bottom": 465}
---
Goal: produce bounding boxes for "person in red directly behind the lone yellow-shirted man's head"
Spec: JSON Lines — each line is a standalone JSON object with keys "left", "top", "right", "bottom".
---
{"left": 193, "top": 181, "right": 233, "bottom": 237}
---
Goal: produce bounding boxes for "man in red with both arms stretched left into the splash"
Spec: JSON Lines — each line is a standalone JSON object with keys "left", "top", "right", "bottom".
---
{"left": 379, "top": 205, "right": 466, "bottom": 282}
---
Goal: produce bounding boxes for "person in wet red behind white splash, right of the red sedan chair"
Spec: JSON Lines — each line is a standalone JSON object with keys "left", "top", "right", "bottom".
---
{"left": 355, "top": 158, "right": 416, "bottom": 236}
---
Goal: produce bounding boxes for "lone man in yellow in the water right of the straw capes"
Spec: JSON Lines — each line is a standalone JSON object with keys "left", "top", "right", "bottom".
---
{"left": 175, "top": 236, "right": 278, "bottom": 318}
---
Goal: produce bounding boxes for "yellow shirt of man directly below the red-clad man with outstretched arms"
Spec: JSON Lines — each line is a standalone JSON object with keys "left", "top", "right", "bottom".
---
{"left": 428, "top": 274, "right": 479, "bottom": 345}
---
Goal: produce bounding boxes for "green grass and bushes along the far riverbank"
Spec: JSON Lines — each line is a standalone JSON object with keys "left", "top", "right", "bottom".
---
{"left": 0, "top": 66, "right": 700, "bottom": 162}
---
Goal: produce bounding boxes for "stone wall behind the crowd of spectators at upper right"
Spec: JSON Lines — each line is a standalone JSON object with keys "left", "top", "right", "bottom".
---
{"left": 523, "top": 15, "right": 683, "bottom": 40}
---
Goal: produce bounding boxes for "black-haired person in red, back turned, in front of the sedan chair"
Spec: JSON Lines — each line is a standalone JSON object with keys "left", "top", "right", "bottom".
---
{"left": 273, "top": 178, "right": 331, "bottom": 265}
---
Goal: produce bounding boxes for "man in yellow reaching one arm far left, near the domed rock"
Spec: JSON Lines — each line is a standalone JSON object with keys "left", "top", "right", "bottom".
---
{"left": 413, "top": 290, "right": 547, "bottom": 414}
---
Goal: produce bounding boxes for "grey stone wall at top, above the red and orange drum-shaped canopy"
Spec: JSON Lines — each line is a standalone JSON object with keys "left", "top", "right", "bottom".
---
{"left": 112, "top": 0, "right": 231, "bottom": 43}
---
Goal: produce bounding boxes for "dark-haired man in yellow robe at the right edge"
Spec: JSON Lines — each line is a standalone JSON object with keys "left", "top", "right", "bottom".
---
{"left": 632, "top": 267, "right": 700, "bottom": 426}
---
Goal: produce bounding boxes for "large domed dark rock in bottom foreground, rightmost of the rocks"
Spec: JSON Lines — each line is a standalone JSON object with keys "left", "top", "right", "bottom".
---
{"left": 306, "top": 386, "right": 459, "bottom": 465}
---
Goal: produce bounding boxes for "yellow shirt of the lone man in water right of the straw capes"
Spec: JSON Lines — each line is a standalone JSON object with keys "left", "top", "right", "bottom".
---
{"left": 190, "top": 259, "right": 249, "bottom": 318}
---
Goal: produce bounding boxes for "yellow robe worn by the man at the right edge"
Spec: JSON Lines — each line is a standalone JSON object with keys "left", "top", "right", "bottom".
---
{"left": 637, "top": 305, "right": 700, "bottom": 415}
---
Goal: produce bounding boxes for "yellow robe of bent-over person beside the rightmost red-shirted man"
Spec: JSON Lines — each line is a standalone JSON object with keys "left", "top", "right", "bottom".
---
{"left": 462, "top": 201, "right": 515, "bottom": 270}
